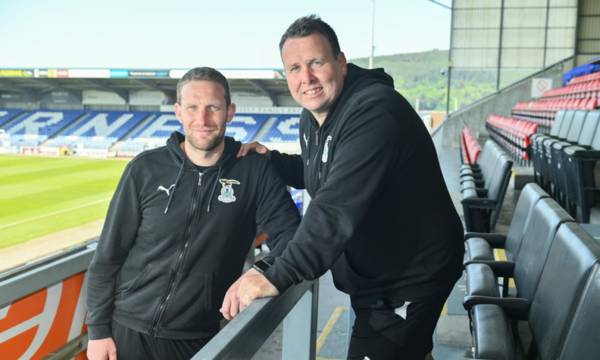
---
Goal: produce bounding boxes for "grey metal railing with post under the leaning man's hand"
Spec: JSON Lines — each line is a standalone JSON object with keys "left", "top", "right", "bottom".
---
{"left": 192, "top": 280, "right": 319, "bottom": 360}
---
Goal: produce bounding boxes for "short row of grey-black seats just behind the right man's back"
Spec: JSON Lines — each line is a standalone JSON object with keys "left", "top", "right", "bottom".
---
{"left": 460, "top": 139, "right": 513, "bottom": 232}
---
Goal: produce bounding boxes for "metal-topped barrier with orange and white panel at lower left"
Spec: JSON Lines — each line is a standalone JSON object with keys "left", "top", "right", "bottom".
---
{"left": 0, "top": 242, "right": 96, "bottom": 359}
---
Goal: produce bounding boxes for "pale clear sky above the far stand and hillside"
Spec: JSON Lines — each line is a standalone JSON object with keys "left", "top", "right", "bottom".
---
{"left": 0, "top": 0, "right": 450, "bottom": 68}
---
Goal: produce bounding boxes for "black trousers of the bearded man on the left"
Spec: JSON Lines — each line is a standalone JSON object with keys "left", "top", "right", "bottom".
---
{"left": 112, "top": 321, "right": 211, "bottom": 360}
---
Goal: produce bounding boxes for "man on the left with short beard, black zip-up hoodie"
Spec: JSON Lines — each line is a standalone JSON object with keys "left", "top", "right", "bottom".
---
{"left": 87, "top": 68, "right": 299, "bottom": 360}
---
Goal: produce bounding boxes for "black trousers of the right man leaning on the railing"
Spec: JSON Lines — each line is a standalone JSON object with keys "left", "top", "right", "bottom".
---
{"left": 348, "top": 292, "right": 449, "bottom": 360}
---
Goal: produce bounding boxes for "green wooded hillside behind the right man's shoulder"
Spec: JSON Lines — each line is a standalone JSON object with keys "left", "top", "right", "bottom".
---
{"left": 350, "top": 50, "right": 496, "bottom": 110}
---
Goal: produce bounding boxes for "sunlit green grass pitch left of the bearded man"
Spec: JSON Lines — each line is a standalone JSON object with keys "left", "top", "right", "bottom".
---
{"left": 0, "top": 155, "right": 127, "bottom": 248}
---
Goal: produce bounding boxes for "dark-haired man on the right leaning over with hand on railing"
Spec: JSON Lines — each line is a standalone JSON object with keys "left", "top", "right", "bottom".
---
{"left": 221, "top": 16, "right": 464, "bottom": 360}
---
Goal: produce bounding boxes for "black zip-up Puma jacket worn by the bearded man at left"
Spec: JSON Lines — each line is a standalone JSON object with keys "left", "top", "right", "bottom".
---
{"left": 87, "top": 133, "right": 300, "bottom": 339}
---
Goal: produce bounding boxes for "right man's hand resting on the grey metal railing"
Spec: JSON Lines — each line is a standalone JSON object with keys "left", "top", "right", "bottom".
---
{"left": 220, "top": 269, "right": 279, "bottom": 320}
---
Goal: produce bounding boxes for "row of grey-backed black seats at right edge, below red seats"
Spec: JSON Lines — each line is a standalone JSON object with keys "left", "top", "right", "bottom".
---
{"left": 532, "top": 111, "right": 600, "bottom": 222}
